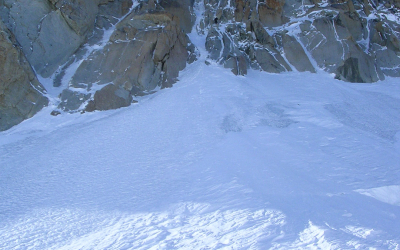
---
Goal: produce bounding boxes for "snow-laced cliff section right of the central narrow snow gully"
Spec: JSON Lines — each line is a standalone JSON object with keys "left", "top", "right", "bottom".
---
{"left": 197, "top": 0, "right": 400, "bottom": 82}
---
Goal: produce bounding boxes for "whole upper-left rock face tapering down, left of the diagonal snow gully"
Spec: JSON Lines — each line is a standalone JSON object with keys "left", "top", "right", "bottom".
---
{"left": 0, "top": 0, "right": 125, "bottom": 77}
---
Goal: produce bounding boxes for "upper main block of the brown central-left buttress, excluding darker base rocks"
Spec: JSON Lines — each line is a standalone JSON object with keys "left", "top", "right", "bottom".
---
{"left": 71, "top": 14, "right": 192, "bottom": 91}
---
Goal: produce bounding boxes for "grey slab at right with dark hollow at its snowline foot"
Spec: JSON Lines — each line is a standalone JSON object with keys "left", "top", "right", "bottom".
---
{"left": 300, "top": 12, "right": 383, "bottom": 82}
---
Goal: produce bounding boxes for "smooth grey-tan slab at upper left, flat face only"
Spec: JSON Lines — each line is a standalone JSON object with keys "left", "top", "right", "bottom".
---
{"left": 0, "top": 0, "right": 83, "bottom": 77}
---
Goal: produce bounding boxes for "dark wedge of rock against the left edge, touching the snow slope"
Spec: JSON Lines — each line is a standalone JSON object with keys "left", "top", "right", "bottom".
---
{"left": 0, "top": 21, "right": 48, "bottom": 131}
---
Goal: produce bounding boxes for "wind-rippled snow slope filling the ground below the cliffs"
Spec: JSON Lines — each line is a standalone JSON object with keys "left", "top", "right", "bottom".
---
{"left": 0, "top": 47, "right": 400, "bottom": 249}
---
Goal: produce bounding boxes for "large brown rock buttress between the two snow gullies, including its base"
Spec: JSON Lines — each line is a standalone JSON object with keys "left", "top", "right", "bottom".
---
{"left": 59, "top": 1, "right": 195, "bottom": 111}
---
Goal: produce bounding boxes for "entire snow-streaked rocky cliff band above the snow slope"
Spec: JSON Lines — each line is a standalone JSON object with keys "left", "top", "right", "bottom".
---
{"left": 0, "top": 0, "right": 400, "bottom": 130}
